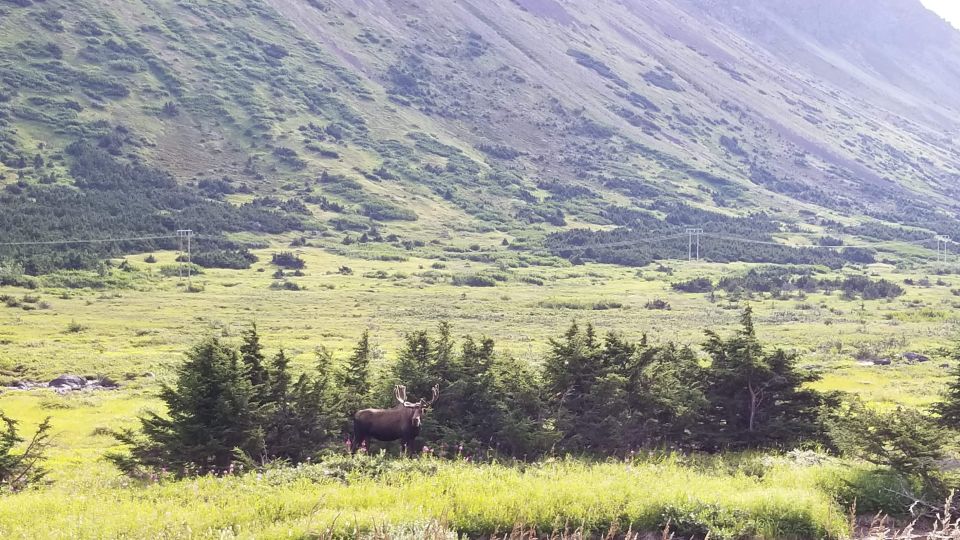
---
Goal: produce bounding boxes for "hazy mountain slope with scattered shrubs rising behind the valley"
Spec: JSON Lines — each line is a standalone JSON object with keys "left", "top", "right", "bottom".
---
{"left": 0, "top": 0, "right": 960, "bottom": 268}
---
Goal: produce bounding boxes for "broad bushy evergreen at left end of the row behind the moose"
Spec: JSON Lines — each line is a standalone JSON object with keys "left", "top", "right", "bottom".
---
{"left": 110, "top": 338, "right": 265, "bottom": 472}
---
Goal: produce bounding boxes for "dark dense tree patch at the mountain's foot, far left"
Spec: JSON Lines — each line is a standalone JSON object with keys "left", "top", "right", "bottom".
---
{"left": 0, "top": 139, "right": 307, "bottom": 275}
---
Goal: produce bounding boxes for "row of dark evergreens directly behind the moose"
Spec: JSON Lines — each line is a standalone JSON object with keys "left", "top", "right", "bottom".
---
{"left": 112, "top": 309, "right": 832, "bottom": 471}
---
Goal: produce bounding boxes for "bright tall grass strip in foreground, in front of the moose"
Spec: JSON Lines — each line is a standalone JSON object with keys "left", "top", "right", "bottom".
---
{"left": 0, "top": 457, "right": 900, "bottom": 539}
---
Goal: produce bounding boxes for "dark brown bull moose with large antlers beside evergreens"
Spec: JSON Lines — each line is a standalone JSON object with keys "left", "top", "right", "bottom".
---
{"left": 351, "top": 385, "right": 440, "bottom": 454}
